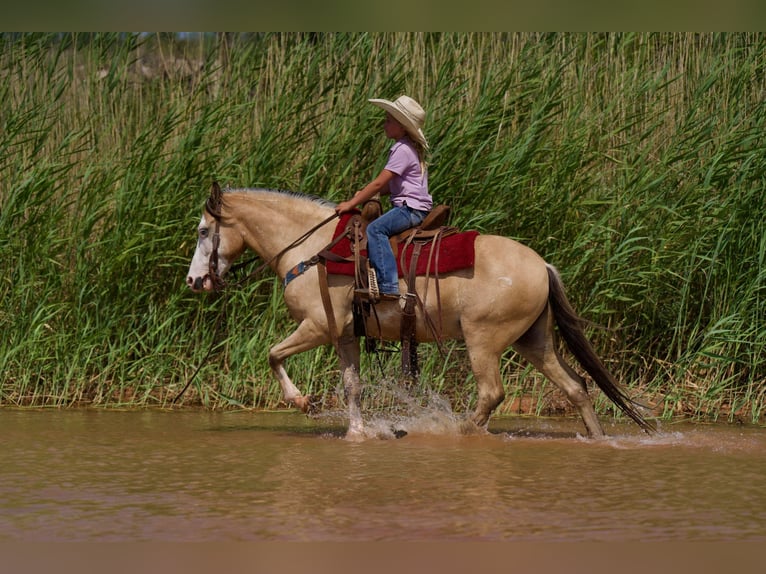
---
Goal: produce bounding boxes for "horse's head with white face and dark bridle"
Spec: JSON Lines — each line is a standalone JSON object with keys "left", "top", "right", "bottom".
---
{"left": 186, "top": 182, "right": 244, "bottom": 292}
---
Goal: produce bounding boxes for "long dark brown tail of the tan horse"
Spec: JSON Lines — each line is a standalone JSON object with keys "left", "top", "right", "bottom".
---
{"left": 546, "top": 264, "right": 657, "bottom": 433}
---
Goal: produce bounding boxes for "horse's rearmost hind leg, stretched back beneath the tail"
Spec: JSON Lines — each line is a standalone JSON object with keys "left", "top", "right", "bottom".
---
{"left": 513, "top": 306, "right": 604, "bottom": 438}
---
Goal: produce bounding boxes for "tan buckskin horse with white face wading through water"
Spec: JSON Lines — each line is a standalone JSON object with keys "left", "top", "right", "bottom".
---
{"left": 186, "top": 183, "right": 656, "bottom": 440}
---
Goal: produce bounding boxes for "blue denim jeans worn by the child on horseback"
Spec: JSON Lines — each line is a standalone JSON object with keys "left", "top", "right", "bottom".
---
{"left": 367, "top": 205, "right": 428, "bottom": 293}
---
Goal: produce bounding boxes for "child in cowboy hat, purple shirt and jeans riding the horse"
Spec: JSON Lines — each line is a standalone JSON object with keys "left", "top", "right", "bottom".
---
{"left": 335, "top": 96, "right": 433, "bottom": 299}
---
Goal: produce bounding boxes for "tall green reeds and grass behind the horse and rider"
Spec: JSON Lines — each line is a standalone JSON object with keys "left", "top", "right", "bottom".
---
{"left": 0, "top": 34, "right": 766, "bottom": 420}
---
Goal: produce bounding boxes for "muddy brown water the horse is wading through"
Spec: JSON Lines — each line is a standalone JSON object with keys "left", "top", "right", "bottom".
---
{"left": 0, "top": 410, "right": 766, "bottom": 542}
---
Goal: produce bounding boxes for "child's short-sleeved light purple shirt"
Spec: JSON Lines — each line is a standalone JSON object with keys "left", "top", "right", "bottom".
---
{"left": 385, "top": 137, "right": 433, "bottom": 211}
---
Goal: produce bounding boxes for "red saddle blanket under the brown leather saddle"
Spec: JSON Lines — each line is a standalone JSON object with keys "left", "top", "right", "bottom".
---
{"left": 327, "top": 214, "right": 479, "bottom": 277}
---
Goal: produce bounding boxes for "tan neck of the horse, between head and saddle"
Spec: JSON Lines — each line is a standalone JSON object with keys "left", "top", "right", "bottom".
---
{"left": 225, "top": 190, "right": 334, "bottom": 277}
